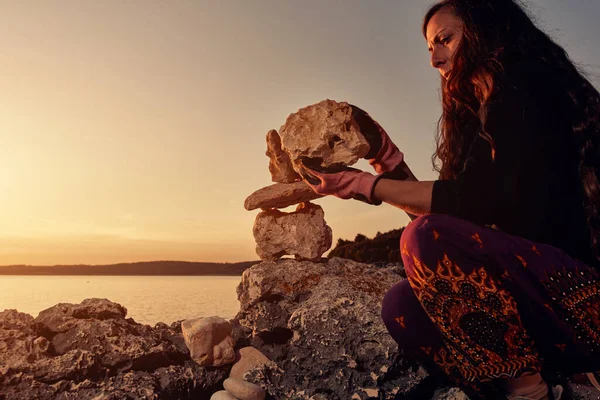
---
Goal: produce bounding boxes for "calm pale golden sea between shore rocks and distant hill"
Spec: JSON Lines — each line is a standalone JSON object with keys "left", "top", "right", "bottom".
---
{"left": 0, "top": 275, "right": 241, "bottom": 326}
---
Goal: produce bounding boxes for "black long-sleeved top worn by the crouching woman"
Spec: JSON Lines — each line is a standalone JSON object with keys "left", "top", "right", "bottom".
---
{"left": 431, "top": 63, "right": 597, "bottom": 265}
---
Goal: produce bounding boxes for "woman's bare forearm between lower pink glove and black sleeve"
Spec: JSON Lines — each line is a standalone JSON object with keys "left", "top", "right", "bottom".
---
{"left": 373, "top": 178, "right": 434, "bottom": 220}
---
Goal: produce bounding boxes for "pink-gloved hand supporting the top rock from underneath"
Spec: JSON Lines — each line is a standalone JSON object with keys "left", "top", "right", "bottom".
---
{"left": 299, "top": 159, "right": 381, "bottom": 205}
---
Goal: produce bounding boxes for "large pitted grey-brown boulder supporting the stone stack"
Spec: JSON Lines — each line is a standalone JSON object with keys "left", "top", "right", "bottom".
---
{"left": 233, "top": 258, "right": 424, "bottom": 400}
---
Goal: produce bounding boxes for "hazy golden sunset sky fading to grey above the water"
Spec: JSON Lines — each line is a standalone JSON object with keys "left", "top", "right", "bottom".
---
{"left": 0, "top": 0, "right": 600, "bottom": 265}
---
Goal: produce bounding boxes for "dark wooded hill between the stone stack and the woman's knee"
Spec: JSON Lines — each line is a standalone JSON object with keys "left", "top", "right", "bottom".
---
{"left": 328, "top": 227, "right": 404, "bottom": 263}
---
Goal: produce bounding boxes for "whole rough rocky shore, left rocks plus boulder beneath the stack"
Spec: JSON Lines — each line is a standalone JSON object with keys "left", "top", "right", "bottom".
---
{"left": 0, "top": 258, "right": 466, "bottom": 400}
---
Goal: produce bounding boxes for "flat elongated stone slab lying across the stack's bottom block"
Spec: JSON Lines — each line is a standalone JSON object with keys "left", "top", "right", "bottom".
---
{"left": 244, "top": 181, "right": 323, "bottom": 211}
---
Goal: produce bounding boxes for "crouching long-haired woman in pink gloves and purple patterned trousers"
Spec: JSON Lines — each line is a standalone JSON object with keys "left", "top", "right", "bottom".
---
{"left": 302, "top": 0, "right": 600, "bottom": 399}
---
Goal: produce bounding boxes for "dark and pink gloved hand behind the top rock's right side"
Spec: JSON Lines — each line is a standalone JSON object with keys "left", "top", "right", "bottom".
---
{"left": 350, "top": 104, "right": 404, "bottom": 174}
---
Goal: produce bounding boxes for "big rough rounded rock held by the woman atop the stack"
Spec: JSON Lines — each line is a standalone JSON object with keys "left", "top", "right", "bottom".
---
{"left": 279, "top": 99, "right": 369, "bottom": 172}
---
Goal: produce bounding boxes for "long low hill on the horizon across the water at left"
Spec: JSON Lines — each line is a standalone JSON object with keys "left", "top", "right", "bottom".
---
{"left": 0, "top": 261, "right": 260, "bottom": 276}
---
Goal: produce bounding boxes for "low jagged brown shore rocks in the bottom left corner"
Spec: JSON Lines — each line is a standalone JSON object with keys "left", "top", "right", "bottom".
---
{"left": 0, "top": 299, "right": 228, "bottom": 400}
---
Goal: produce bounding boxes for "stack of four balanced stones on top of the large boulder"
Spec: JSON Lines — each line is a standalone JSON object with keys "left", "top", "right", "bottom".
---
{"left": 244, "top": 100, "right": 369, "bottom": 261}
